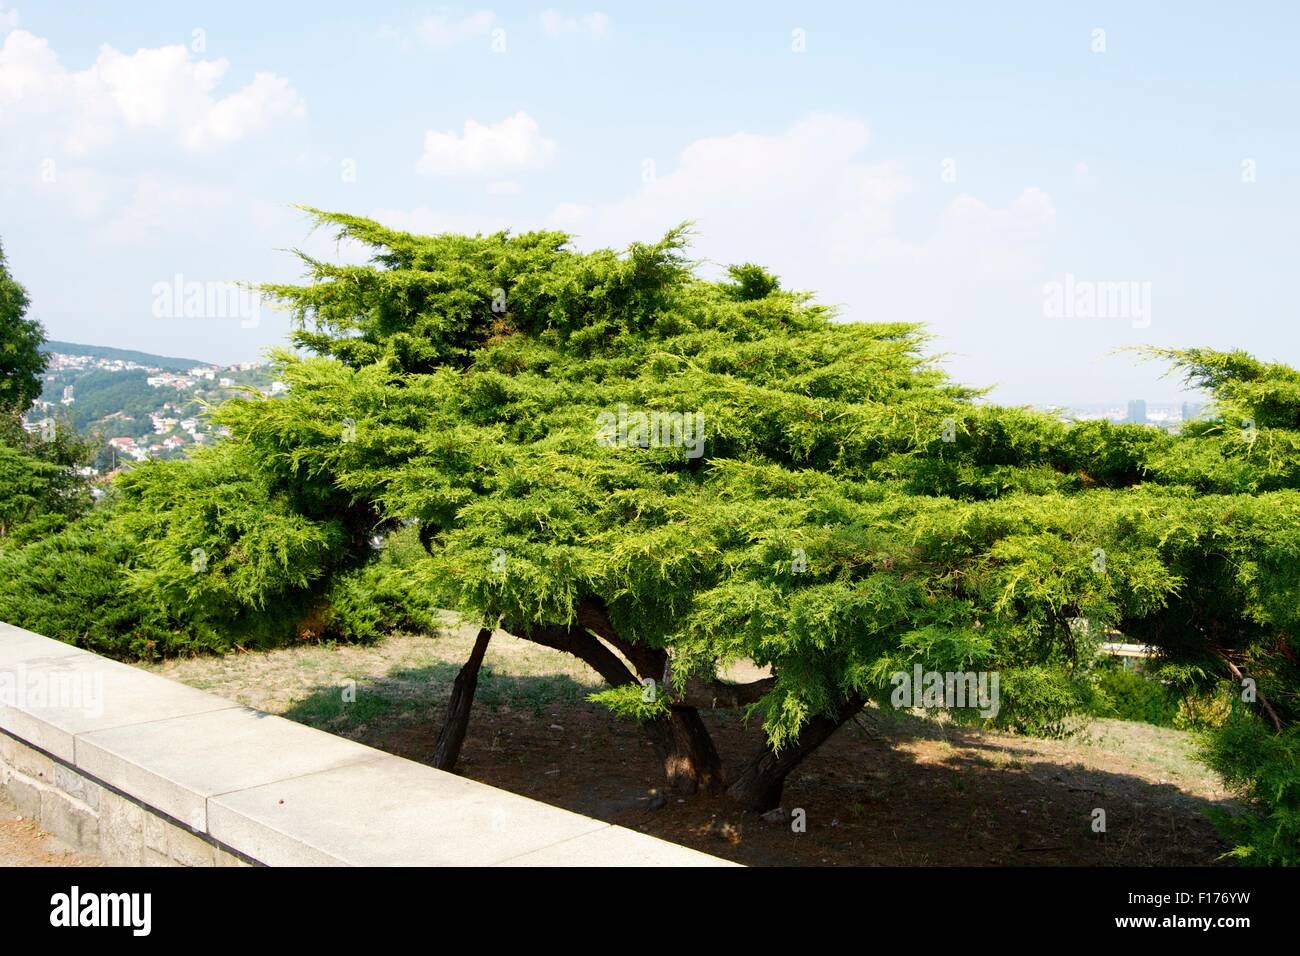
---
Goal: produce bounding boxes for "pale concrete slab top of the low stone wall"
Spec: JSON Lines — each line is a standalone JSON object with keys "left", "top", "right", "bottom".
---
{"left": 0, "top": 623, "right": 732, "bottom": 866}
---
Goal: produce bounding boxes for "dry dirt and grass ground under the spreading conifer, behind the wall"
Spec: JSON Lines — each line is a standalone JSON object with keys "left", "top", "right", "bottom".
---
{"left": 153, "top": 628, "right": 1232, "bottom": 866}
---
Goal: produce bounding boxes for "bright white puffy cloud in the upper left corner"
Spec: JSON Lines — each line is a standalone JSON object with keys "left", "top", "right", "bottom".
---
{"left": 0, "top": 30, "right": 304, "bottom": 153}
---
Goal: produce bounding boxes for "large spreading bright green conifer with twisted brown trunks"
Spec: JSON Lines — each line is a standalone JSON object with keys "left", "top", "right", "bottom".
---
{"left": 210, "top": 212, "right": 1300, "bottom": 809}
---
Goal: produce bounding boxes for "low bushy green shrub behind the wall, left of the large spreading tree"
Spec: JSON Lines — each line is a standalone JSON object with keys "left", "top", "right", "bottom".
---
{"left": 0, "top": 442, "right": 432, "bottom": 658}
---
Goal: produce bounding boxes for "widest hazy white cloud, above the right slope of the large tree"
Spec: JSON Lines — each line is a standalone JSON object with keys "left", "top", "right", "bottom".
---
{"left": 551, "top": 113, "right": 1056, "bottom": 277}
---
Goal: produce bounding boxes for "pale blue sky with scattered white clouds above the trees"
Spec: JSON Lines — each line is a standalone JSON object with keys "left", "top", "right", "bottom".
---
{"left": 0, "top": 0, "right": 1300, "bottom": 405}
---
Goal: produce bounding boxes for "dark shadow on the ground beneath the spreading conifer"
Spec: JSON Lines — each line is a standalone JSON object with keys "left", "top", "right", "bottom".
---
{"left": 285, "top": 663, "right": 1232, "bottom": 866}
